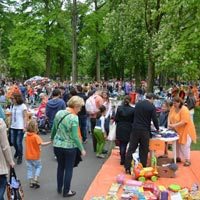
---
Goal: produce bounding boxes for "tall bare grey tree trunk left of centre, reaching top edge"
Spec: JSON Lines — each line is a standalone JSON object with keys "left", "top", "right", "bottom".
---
{"left": 72, "top": 0, "right": 78, "bottom": 83}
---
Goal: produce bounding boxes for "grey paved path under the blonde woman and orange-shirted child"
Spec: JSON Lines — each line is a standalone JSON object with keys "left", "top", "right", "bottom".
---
{"left": 10, "top": 135, "right": 108, "bottom": 200}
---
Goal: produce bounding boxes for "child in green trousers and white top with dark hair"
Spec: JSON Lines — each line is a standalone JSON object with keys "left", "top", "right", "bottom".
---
{"left": 94, "top": 105, "right": 107, "bottom": 158}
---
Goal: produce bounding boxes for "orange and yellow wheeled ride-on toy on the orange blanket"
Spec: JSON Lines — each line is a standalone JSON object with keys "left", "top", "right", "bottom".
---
{"left": 131, "top": 154, "right": 158, "bottom": 182}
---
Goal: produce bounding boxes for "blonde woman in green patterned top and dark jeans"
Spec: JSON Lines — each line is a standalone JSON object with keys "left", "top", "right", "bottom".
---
{"left": 51, "top": 96, "right": 86, "bottom": 197}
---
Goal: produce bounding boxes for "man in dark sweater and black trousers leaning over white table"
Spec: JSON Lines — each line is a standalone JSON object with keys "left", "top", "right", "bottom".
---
{"left": 125, "top": 93, "right": 159, "bottom": 173}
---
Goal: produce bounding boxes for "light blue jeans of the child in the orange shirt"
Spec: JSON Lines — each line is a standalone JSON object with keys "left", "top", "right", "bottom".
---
{"left": 26, "top": 160, "right": 42, "bottom": 179}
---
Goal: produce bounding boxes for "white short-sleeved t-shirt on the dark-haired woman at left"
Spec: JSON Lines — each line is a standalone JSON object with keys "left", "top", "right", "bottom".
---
{"left": 11, "top": 103, "right": 27, "bottom": 129}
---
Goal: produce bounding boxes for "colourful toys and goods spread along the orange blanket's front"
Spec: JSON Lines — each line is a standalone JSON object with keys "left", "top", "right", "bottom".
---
{"left": 91, "top": 174, "right": 200, "bottom": 200}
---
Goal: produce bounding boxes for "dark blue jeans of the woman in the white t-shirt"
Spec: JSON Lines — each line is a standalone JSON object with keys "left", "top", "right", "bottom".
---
{"left": 10, "top": 128, "right": 24, "bottom": 157}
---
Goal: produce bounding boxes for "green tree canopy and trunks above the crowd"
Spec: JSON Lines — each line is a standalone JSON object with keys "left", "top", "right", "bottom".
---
{"left": 0, "top": 0, "right": 200, "bottom": 91}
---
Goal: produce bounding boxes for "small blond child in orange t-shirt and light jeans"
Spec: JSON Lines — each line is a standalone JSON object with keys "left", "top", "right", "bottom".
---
{"left": 25, "top": 119, "right": 51, "bottom": 188}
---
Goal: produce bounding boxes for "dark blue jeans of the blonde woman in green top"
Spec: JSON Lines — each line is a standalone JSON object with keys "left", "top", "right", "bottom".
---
{"left": 54, "top": 147, "right": 77, "bottom": 194}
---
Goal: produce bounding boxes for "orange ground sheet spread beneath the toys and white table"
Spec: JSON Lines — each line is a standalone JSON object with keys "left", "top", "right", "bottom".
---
{"left": 84, "top": 149, "right": 200, "bottom": 200}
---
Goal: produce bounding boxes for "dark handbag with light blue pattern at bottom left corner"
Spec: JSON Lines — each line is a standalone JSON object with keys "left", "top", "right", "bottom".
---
{"left": 6, "top": 167, "right": 24, "bottom": 200}
